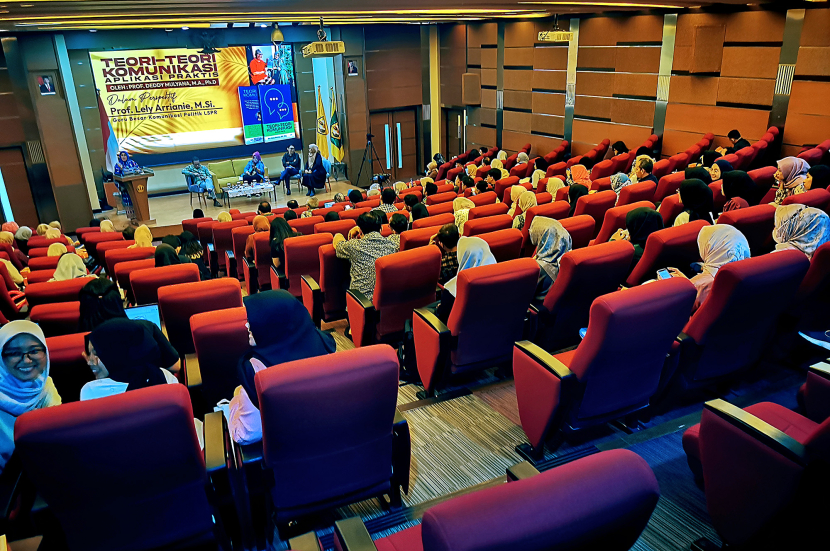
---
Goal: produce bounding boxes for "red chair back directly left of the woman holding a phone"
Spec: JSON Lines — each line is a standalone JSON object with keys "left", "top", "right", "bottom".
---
{"left": 625, "top": 220, "right": 709, "bottom": 287}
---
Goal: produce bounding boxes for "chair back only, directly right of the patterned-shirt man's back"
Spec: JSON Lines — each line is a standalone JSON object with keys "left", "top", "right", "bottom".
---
{"left": 372, "top": 247, "right": 441, "bottom": 337}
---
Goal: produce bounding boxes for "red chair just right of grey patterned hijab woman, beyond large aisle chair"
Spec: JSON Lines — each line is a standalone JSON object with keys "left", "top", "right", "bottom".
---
{"left": 531, "top": 241, "right": 634, "bottom": 351}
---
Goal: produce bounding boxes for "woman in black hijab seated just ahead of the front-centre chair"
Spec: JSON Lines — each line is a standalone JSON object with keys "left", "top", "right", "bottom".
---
{"left": 229, "top": 290, "right": 336, "bottom": 444}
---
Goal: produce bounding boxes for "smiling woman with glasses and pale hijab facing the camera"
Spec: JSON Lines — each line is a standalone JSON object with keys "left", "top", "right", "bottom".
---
{"left": 0, "top": 320, "right": 61, "bottom": 471}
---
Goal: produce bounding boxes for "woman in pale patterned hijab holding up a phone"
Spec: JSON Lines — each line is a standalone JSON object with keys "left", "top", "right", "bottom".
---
{"left": 667, "top": 224, "right": 751, "bottom": 312}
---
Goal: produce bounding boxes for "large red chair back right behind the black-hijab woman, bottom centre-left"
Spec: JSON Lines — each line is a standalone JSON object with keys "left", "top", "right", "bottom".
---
{"left": 255, "top": 345, "right": 399, "bottom": 519}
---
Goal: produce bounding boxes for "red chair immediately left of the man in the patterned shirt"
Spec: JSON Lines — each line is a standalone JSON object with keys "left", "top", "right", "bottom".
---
{"left": 300, "top": 244, "right": 352, "bottom": 327}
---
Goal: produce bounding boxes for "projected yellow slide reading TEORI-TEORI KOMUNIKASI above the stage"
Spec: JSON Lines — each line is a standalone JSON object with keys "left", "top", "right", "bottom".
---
{"left": 89, "top": 45, "right": 299, "bottom": 158}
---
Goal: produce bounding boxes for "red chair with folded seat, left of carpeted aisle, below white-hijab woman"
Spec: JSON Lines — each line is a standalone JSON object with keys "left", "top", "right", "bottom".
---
{"left": 412, "top": 258, "right": 539, "bottom": 393}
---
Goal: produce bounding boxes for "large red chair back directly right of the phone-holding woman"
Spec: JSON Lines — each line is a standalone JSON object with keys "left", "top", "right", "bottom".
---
{"left": 668, "top": 250, "right": 810, "bottom": 389}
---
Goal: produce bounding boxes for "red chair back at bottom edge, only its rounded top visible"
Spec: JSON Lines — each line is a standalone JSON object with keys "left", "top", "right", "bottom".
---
{"left": 420, "top": 450, "right": 660, "bottom": 551}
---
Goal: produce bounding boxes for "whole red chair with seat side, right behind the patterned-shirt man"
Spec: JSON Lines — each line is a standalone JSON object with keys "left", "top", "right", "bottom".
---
{"left": 346, "top": 247, "right": 441, "bottom": 347}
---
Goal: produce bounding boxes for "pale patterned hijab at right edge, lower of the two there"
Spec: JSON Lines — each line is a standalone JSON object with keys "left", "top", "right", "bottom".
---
{"left": 772, "top": 204, "right": 830, "bottom": 258}
